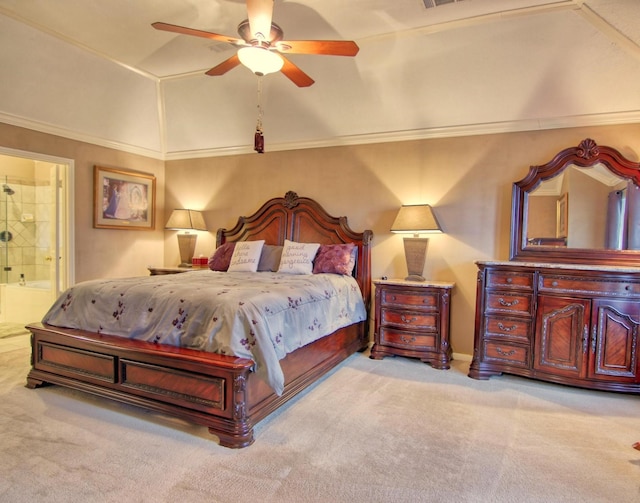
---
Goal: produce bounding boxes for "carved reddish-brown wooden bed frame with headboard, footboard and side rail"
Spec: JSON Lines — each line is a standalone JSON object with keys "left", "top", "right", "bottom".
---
{"left": 27, "top": 192, "right": 372, "bottom": 448}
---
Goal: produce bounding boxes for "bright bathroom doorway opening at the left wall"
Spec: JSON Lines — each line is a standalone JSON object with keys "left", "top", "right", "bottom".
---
{"left": 0, "top": 148, "right": 74, "bottom": 338}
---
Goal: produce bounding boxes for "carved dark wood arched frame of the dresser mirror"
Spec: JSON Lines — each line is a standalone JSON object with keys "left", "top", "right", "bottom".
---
{"left": 510, "top": 138, "right": 640, "bottom": 267}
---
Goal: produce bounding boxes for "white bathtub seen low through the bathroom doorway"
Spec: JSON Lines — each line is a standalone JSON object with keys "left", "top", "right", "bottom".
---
{"left": 0, "top": 280, "right": 55, "bottom": 324}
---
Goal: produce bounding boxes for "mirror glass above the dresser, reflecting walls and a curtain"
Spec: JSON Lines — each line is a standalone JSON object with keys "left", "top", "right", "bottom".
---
{"left": 526, "top": 163, "right": 640, "bottom": 250}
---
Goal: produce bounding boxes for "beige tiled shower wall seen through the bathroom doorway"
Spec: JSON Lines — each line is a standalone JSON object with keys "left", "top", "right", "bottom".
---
{"left": 0, "top": 178, "right": 51, "bottom": 283}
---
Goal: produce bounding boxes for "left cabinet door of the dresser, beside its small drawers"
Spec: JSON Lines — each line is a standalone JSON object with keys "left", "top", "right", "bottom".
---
{"left": 534, "top": 295, "right": 591, "bottom": 377}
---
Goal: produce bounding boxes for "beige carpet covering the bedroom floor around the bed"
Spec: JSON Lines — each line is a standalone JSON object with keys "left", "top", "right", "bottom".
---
{"left": 0, "top": 338, "right": 640, "bottom": 503}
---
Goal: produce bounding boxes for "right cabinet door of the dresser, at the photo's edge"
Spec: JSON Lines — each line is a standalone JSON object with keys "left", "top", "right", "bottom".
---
{"left": 589, "top": 299, "right": 640, "bottom": 383}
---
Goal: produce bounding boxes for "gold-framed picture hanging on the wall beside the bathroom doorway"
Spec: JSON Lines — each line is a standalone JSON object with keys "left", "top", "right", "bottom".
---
{"left": 93, "top": 166, "right": 156, "bottom": 230}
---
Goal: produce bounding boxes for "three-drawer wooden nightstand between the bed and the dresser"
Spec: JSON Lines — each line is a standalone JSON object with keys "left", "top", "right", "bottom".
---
{"left": 370, "top": 279, "right": 455, "bottom": 369}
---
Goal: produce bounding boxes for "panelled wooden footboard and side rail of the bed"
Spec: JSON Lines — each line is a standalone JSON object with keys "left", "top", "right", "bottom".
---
{"left": 26, "top": 323, "right": 366, "bottom": 448}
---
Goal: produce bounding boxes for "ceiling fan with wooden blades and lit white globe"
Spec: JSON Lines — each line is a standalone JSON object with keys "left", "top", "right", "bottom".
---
{"left": 152, "top": 0, "right": 359, "bottom": 87}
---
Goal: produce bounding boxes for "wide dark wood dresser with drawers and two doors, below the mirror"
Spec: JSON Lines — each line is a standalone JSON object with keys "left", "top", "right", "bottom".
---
{"left": 469, "top": 261, "right": 640, "bottom": 393}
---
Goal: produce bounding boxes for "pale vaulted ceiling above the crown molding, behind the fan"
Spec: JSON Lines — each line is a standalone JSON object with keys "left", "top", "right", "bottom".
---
{"left": 0, "top": 0, "right": 640, "bottom": 159}
